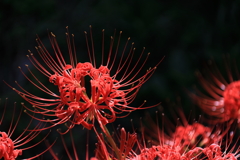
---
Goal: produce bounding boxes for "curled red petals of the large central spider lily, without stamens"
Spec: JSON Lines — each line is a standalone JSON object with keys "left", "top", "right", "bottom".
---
{"left": 49, "top": 62, "right": 121, "bottom": 129}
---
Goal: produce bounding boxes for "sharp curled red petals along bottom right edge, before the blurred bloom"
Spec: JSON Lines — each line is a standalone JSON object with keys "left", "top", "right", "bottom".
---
{"left": 132, "top": 131, "right": 240, "bottom": 160}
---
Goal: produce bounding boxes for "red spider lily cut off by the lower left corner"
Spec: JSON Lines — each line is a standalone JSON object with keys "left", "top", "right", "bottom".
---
{"left": 0, "top": 99, "right": 52, "bottom": 160}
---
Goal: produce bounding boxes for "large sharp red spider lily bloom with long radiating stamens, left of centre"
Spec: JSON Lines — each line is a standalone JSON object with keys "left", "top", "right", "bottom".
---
{"left": 6, "top": 26, "right": 163, "bottom": 134}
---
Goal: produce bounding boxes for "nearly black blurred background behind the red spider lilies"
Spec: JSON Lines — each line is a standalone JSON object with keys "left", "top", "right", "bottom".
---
{"left": 0, "top": 0, "right": 240, "bottom": 158}
